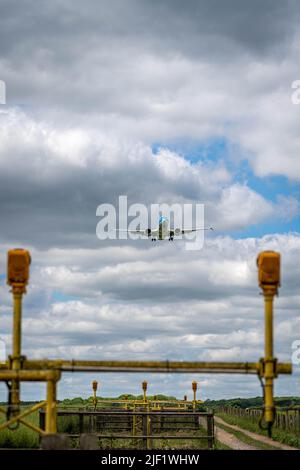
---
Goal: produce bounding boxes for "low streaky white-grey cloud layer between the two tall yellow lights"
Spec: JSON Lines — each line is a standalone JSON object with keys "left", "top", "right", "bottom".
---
{"left": 2, "top": 234, "right": 300, "bottom": 360}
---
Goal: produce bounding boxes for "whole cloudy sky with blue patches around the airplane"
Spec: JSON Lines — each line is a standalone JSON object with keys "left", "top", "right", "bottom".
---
{"left": 0, "top": 0, "right": 300, "bottom": 400}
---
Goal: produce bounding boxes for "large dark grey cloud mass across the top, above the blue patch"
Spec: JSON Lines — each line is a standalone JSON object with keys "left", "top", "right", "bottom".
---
{"left": 0, "top": 0, "right": 300, "bottom": 181}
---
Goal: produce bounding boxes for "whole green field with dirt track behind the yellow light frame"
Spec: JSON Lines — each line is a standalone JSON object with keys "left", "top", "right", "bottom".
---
{"left": 0, "top": 395, "right": 300, "bottom": 450}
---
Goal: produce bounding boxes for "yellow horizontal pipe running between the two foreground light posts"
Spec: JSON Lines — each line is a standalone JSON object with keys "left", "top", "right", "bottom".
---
{"left": 0, "top": 359, "right": 292, "bottom": 374}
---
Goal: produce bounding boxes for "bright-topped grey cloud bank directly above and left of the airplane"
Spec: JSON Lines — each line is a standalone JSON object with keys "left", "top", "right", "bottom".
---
{"left": 0, "top": 110, "right": 288, "bottom": 247}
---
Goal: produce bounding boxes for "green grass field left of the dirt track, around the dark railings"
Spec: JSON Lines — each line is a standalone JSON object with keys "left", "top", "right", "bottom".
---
{"left": 0, "top": 396, "right": 220, "bottom": 449}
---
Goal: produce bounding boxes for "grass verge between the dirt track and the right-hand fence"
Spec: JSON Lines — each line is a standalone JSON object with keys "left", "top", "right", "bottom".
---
{"left": 216, "top": 413, "right": 300, "bottom": 449}
